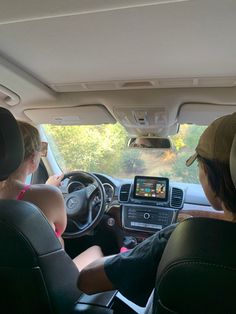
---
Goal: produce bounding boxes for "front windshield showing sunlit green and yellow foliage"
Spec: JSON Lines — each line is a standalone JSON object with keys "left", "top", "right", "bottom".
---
{"left": 43, "top": 123, "right": 205, "bottom": 183}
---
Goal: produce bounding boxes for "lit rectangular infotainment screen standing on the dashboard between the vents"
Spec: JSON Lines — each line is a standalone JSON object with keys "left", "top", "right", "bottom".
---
{"left": 134, "top": 176, "right": 169, "bottom": 202}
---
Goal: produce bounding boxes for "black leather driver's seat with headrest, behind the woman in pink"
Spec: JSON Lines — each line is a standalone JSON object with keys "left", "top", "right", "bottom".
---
{"left": 0, "top": 108, "right": 81, "bottom": 314}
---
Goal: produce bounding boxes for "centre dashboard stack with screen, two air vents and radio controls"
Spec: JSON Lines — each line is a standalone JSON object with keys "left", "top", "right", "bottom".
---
{"left": 119, "top": 176, "right": 184, "bottom": 233}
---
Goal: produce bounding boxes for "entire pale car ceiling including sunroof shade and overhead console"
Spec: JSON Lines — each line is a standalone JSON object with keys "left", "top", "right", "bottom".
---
{"left": 0, "top": 0, "right": 236, "bottom": 134}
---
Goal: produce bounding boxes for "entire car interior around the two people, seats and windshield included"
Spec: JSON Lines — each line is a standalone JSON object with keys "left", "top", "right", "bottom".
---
{"left": 0, "top": 0, "right": 236, "bottom": 314}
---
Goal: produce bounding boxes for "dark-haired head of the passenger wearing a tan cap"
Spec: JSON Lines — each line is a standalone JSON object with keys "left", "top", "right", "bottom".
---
{"left": 186, "top": 113, "right": 236, "bottom": 213}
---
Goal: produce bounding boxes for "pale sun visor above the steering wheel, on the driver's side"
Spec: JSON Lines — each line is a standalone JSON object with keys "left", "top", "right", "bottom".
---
{"left": 24, "top": 105, "right": 116, "bottom": 125}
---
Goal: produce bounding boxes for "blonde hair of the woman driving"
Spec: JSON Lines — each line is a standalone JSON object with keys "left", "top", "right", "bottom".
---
{"left": 17, "top": 121, "right": 41, "bottom": 160}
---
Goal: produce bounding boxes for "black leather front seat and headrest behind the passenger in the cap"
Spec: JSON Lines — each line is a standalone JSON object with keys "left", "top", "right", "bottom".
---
{"left": 152, "top": 135, "right": 236, "bottom": 314}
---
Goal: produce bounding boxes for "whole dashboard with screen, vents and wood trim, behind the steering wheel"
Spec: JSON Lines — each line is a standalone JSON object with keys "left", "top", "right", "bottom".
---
{"left": 61, "top": 173, "right": 225, "bottom": 250}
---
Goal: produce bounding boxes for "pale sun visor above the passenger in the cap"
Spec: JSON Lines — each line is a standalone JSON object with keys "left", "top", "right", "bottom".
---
{"left": 177, "top": 103, "right": 236, "bottom": 125}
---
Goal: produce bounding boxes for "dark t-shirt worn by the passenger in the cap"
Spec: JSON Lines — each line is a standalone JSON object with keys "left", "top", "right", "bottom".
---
{"left": 104, "top": 224, "right": 177, "bottom": 306}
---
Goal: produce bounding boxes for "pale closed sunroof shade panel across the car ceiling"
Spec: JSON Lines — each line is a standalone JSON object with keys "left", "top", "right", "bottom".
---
{"left": 0, "top": 0, "right": 236, "bottom": 85}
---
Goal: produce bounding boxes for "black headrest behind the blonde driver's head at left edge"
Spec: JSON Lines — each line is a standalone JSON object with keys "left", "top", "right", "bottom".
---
{"left": 0, "top": 107, "right": 24, "bottom": 181}
